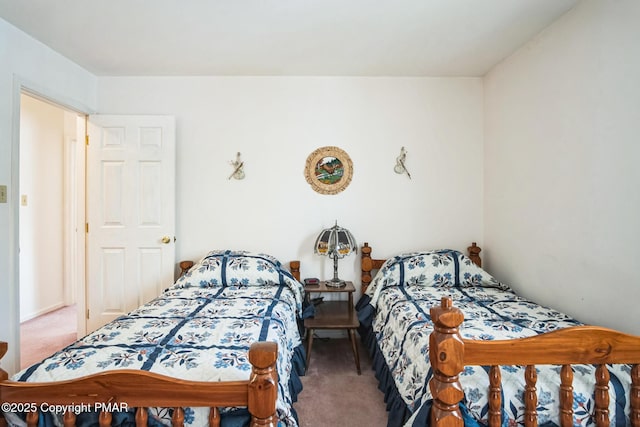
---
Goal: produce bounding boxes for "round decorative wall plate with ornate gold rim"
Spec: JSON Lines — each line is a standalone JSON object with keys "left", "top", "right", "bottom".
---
{"left": 304, "top": 147, "right": 353, "bottom": 194}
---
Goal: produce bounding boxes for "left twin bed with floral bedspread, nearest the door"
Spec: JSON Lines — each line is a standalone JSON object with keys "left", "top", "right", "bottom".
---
{"left": 0, "top": 251, "right": 304, "bottom": 427}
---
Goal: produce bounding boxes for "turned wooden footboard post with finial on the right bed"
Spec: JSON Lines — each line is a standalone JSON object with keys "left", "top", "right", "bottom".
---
{"left": 429, "top": 297, "right": 464, "bottom": 427}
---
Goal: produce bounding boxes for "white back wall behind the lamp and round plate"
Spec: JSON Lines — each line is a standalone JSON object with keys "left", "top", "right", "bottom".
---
{"left": 98, "top": 77, "right": 483, "bottom": 298}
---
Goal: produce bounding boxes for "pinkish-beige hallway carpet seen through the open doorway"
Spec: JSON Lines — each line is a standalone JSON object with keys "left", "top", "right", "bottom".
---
{"left": 20, "top": 305, "right": 78, "bottom": 369}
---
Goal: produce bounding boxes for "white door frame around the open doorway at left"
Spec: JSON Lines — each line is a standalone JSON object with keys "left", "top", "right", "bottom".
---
{"left": 7, "top": 75, "right": 94, "bottom": 372}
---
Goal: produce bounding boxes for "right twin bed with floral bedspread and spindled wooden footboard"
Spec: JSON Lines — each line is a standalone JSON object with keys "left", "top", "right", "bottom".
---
{"left": 357, "top": 243, "right": 640, "bottom": 427}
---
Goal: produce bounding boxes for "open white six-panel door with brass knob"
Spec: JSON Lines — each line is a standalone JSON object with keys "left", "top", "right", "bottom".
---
{"left": 86, "top": 115, "right": 175, "bottom": 332}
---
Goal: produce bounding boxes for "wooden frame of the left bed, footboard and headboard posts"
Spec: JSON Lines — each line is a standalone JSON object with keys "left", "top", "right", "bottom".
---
{"left": 0, "top": 261, "right": 300, "bottom": 427}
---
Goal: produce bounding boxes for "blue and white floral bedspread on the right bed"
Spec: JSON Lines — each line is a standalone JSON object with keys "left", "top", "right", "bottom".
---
{"left": 357, "top": 250, "right": 631, "bottom": 426}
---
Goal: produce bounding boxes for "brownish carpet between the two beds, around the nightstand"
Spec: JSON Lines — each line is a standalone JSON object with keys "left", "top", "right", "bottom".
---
{"left": 294, "top": 338, "right": 387, "bottom": 427}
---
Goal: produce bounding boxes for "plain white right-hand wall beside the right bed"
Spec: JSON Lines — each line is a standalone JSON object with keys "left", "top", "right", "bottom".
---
{"left": 484, "top": 0, "right": 640, "bottom": 334}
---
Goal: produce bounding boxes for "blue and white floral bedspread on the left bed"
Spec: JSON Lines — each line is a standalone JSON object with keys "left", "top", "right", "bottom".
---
{"left": 5, "top": 251, "right": 304, "bottom": 426}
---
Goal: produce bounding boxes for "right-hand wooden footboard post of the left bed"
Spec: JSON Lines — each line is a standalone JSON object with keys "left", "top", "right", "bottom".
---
{"left": 248, "top": 342, "right": 278, "bottom": 427}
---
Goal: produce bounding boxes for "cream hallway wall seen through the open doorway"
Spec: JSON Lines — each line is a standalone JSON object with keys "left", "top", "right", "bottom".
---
{"left": 19, "top": 95, "right": 65, "bottom": 321}
